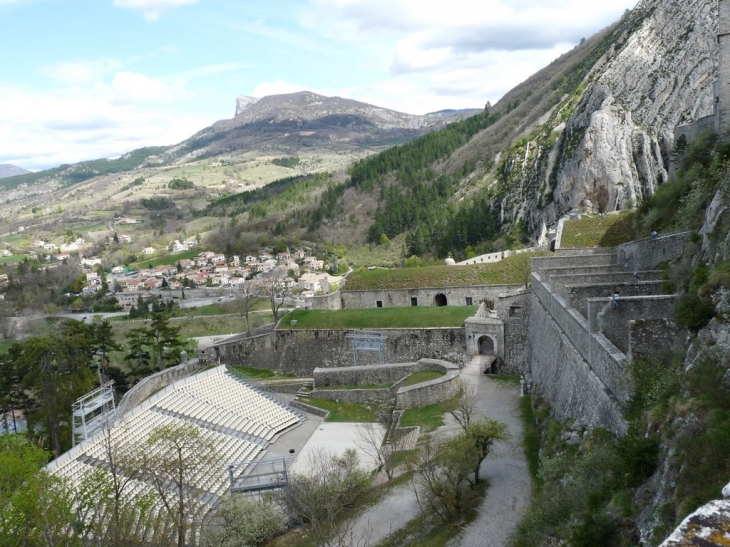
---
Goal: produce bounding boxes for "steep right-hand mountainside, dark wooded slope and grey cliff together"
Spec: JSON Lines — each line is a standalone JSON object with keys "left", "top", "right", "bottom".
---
{"left": 298, "top": 0, "right": 716, "bottom": 259}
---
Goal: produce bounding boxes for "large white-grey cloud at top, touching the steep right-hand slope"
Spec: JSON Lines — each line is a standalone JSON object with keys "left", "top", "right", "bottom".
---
{"left": 308, "top": 0, "right": 634, "bottom": 74}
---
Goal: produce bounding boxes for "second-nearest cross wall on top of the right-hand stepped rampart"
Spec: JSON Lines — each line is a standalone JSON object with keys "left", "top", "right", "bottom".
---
{"left": 588, "top": 295, "right": 677, "bottom": 354}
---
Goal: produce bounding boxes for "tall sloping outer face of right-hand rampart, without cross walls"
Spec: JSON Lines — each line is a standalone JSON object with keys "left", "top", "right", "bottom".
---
{"left": 529, "top": 295, "right": 626, "bottom": 435}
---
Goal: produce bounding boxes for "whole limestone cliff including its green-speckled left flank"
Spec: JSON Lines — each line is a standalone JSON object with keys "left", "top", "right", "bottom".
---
{"left": 487, "top": 0, "right": 718, "bottom": 235}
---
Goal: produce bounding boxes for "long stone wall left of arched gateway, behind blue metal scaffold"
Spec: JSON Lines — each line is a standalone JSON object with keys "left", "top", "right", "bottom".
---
{"left": 209, "top": 328, "right": 466, "bottom": 376}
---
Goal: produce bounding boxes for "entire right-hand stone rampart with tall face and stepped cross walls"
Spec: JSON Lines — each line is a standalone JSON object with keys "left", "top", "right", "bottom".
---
{"left": 528, "top": 233, "right": 689, "bottom": 434}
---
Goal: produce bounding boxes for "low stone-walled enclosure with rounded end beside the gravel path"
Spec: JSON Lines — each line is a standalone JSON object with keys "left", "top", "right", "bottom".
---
{"left": 311, "top": 359, "right": 461, "bottom": 410}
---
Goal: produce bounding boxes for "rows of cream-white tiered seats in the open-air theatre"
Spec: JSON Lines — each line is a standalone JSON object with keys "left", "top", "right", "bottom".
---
{"left": 47, "top": 366, "right": 301, "bottom": 503}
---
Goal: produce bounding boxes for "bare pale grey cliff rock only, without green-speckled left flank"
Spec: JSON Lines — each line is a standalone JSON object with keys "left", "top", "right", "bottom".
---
{"left": 554, "top": 0, "right": 717, "bottom": 212}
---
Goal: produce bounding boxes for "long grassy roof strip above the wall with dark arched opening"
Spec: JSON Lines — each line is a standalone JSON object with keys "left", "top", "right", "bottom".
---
{"left": 342, "top": 252, "right": 548, "bottom": 291}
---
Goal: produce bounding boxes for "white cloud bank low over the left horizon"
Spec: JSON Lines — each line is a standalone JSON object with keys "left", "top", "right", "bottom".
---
{"left": 0, "top": 72, "right": 205, "bottom": 169}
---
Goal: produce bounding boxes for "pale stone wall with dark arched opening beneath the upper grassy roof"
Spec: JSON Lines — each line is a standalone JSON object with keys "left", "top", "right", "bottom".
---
{"left": 341, "top": 285, "right": 520, "bottom": 308}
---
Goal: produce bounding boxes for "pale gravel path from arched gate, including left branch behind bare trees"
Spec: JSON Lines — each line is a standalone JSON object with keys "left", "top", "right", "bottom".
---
{"left": 346, "top": 361, "right": 531, "bottom": 547}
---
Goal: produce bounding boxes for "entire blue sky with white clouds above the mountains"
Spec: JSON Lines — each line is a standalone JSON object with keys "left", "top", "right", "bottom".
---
{"left": 0, "top": 0, "right": 635, "bottom": 170}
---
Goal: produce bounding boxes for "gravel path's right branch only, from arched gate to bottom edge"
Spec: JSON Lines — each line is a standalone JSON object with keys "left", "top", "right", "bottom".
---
{"left": 459, "top": 362, "right": 532, "bottom": 547}
